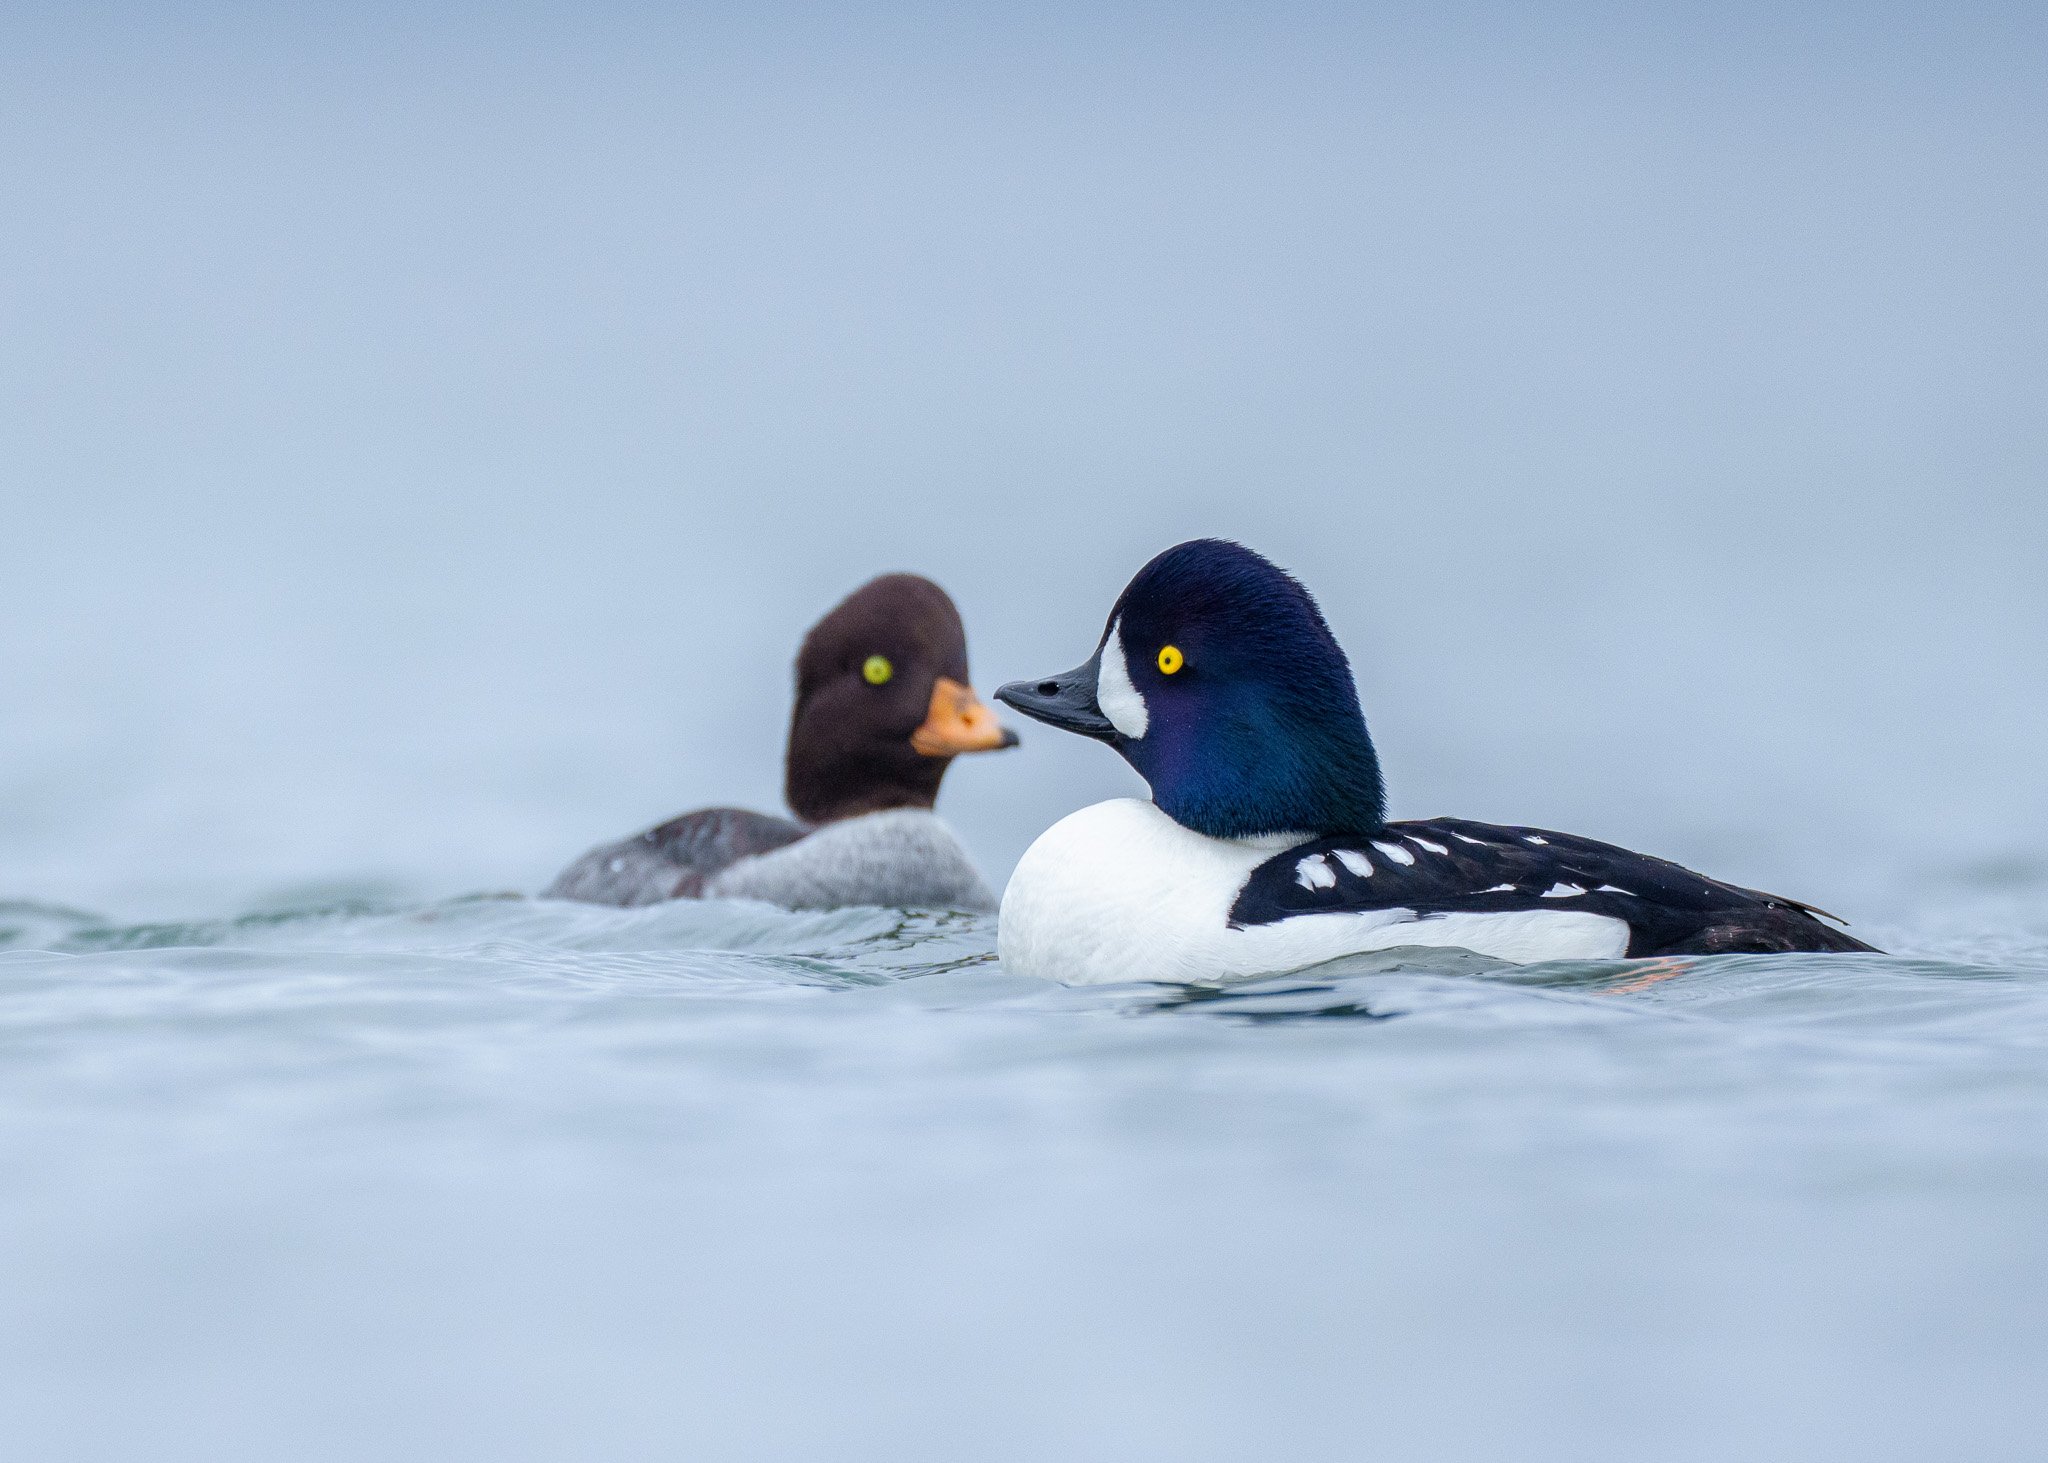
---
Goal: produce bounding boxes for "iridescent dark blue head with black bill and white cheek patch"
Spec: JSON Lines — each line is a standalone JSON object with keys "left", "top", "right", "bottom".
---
{"left": 995, "top": 539, "right": 1386, "bottom": 838}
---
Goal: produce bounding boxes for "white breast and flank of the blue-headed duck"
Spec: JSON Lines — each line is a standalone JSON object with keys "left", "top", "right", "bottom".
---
{"left": 995, "top": 797, "right": 1628, "bottom": 986}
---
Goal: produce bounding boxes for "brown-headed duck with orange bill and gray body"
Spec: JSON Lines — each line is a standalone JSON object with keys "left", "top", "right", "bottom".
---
{"left": 543, "top": 574, "right": 1018, "bottom": 910}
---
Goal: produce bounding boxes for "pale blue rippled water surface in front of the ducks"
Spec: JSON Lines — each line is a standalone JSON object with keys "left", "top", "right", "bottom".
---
{"left": 0, "top": 895, "right": 2048, "bottom": 1459}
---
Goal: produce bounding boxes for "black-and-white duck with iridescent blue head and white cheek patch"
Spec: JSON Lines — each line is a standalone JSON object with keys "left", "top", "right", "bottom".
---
{"left": 995, "top": 539, "right": 1870, "bottom": 984}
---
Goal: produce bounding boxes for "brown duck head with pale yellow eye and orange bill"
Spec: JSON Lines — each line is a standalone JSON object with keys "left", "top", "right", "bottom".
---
{"left": 784, "top": 574, "right": 1018, "bottom": 824}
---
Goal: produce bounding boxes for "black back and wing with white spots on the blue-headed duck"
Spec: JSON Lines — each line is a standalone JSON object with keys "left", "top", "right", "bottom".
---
{"left": 1231, "top": 818, "right": 1872, "bottom": 957}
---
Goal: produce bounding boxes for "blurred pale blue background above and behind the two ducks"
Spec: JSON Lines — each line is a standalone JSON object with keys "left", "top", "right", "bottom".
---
{"left": 0, "top": 6, "right": 2048, "bottom": 912}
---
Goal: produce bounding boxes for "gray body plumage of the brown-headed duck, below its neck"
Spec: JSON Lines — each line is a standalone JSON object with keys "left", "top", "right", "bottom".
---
{"left": 543, "top": 807, "right": 995, "bottom": 910}
